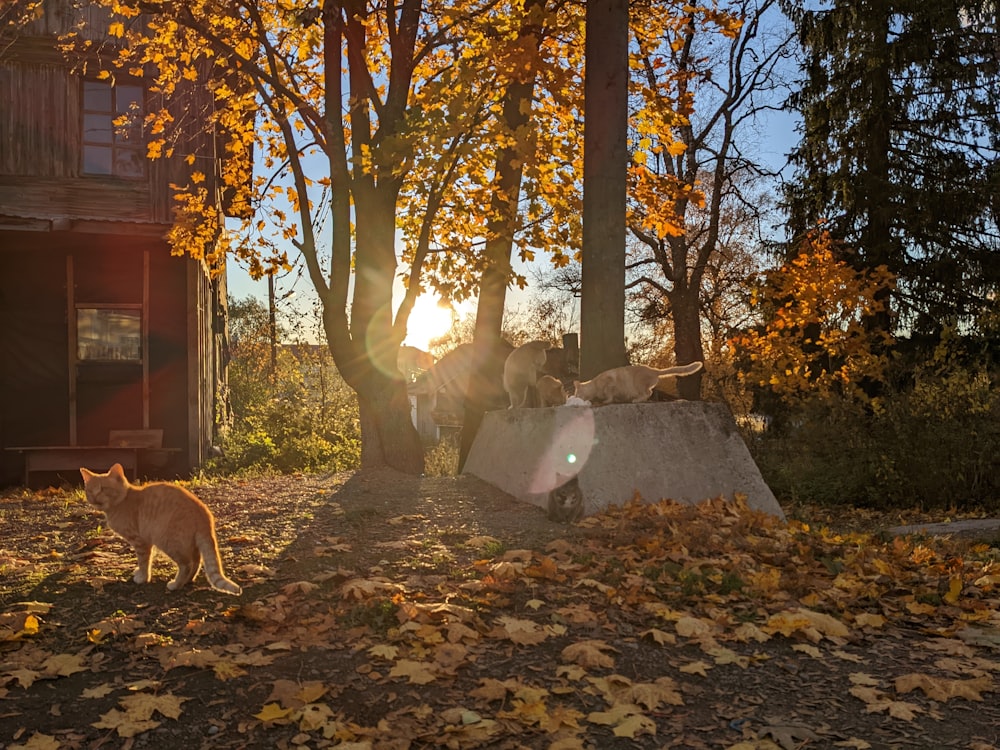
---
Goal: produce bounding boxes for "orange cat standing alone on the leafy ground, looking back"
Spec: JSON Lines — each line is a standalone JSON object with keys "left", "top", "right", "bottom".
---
{"left": 80, "top": 464, "right": 243, "bottom": 596}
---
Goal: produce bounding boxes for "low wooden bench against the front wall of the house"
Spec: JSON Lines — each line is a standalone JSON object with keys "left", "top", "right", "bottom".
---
{"left": 7, "top": 430, "right": 179, "bottom": 487}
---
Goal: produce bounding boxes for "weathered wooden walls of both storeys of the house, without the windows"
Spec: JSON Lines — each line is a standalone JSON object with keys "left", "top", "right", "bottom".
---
{"left": 0, "top": 0, "right": 225, "bottom": 484}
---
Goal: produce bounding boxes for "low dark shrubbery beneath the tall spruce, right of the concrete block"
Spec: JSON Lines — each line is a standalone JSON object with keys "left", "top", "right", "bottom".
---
{"left": 746, "top": 358, "right": 1000, "bottom": 508}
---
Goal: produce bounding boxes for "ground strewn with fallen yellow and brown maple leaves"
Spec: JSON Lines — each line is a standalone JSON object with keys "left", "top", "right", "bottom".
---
{"left": 0, "top": 472, "right": 1000, "bottom": 750}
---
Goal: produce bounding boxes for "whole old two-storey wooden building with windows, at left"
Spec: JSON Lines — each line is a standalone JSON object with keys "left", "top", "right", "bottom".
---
{"left": 0, "top": 0, "right": 232, "bottom": 485}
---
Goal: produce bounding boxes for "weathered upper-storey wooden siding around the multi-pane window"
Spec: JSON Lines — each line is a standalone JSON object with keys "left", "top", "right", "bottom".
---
{"left": 0, "top": 0, "right": 223, "bottom": 225}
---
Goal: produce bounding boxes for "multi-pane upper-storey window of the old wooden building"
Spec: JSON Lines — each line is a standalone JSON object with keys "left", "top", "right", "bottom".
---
{"left": 83, "top": 80, "right": 146, "bottom": 179}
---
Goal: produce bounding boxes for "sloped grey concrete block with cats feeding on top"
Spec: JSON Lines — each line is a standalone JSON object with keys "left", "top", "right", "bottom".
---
{"left": 465, "top": 401, "right": 784, "bottom": 518}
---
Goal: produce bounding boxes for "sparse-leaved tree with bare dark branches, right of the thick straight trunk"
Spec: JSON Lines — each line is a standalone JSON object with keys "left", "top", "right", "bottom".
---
{"left": 628, "top": 0, "right": 791, "bottom": 398}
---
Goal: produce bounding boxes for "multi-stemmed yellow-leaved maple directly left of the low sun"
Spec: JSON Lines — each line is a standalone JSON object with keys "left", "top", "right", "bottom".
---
{"left": 68, "top": 0, "right": 592, "bottom": 473}
